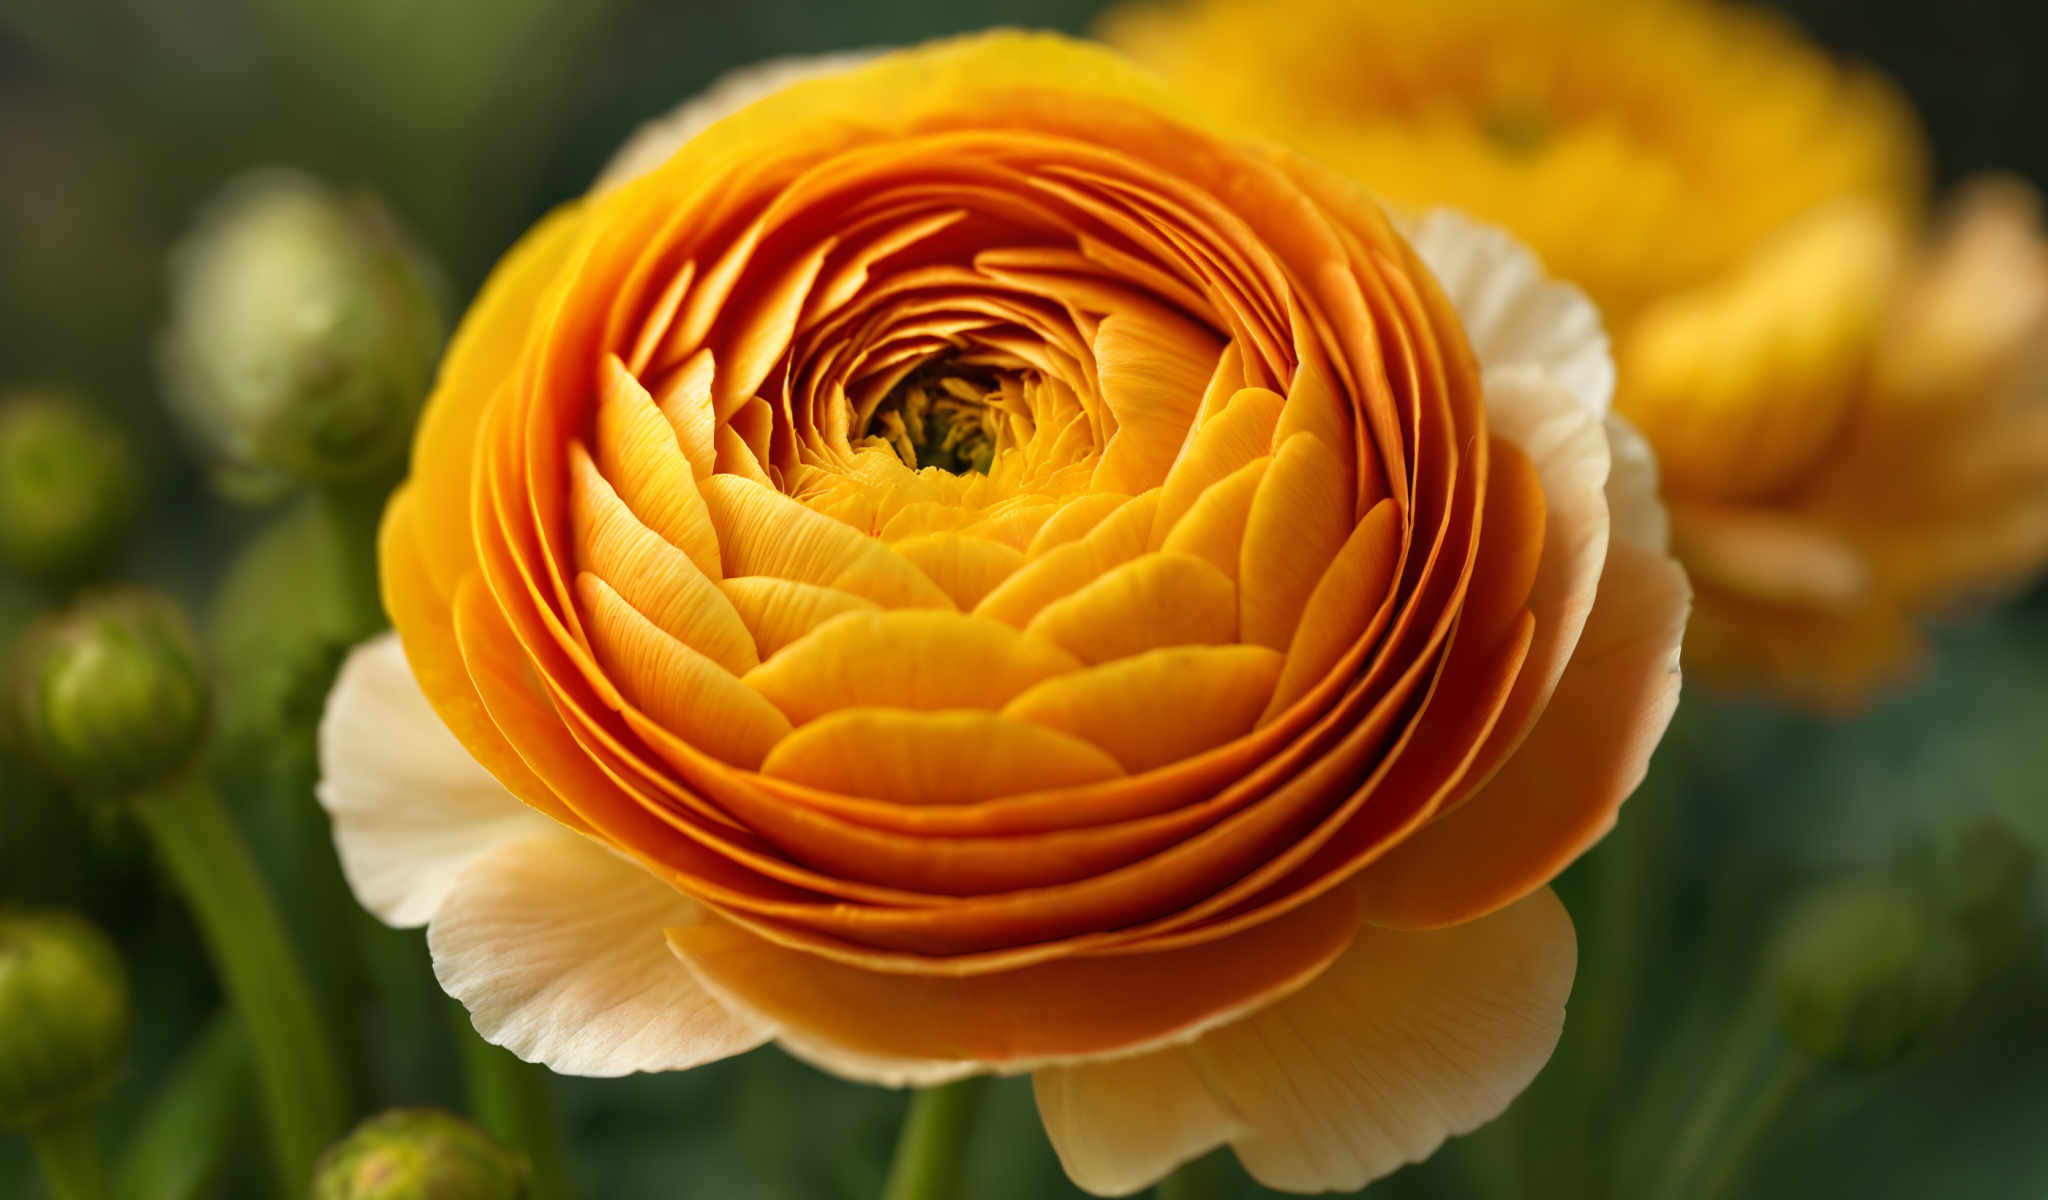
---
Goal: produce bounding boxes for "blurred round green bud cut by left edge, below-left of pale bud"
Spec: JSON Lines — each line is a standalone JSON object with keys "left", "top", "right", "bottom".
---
{"left": 0, "top": 393, "right": 141, "bottom": 582}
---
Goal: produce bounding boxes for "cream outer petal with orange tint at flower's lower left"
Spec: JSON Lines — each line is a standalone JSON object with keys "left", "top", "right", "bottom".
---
{"left": 426, "top": 827, "right": 768, "bottom": 1077}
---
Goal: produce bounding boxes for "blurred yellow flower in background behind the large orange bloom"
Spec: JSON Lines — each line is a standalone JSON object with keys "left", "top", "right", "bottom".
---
{"left": 1104, "top": 0, "right": 2048, "bottom": 706}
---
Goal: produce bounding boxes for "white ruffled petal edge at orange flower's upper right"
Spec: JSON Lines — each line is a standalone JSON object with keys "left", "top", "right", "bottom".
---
{"left": 1395, "top": 209, "right": 1614, "bottom": 414}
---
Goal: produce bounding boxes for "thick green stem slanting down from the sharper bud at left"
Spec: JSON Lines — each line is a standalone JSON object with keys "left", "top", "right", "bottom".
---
{"left": 135, "top": 772, "right": 344, "bottom": 1196}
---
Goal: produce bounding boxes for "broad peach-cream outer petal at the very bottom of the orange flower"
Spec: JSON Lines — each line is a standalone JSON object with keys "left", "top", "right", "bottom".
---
{"left": 1034, "top": 889, "right": 1577, "bottom": 1196}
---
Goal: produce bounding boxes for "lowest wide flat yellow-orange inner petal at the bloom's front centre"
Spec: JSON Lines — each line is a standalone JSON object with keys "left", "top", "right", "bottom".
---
{"left": 762, "top": 709, "right": 1122, "bottom": 805}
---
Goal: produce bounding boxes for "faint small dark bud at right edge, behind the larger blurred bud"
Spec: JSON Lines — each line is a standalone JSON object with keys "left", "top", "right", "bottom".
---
{"left": 1927, "top": 813, "right": 2040, "bottom": 971}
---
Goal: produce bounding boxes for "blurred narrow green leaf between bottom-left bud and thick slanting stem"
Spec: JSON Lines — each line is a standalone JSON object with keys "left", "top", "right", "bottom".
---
{"left": 117, "top": 1012, "right": 254, "bottom": 1200}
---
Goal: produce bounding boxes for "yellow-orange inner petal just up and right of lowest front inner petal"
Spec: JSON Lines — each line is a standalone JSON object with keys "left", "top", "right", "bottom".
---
{"left": 1004, "top": 645, "right": 1280, "bottom": 774}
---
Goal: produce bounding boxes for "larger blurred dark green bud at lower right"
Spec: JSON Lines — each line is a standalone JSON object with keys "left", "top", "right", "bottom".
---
{"left": 1778, "top": 881, "right": 1972, "bottom": 1069}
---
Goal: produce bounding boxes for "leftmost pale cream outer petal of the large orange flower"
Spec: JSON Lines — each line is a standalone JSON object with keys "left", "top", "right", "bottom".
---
{"left": 317, "top": 633, "right": 553, "bottom": 928}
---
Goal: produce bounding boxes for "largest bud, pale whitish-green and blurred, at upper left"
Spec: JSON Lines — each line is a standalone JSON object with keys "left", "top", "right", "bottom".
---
{"left": 160, "top": 168, "right": 442, "bottom": 496}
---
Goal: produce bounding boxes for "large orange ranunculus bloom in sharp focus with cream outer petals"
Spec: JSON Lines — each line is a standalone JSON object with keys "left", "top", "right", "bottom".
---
{"left": 322, "top": 35, "right": 1686, "bottom": 1194}
